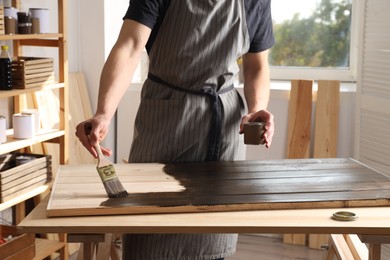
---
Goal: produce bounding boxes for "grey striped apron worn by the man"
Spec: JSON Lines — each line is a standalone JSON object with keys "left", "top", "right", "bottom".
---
{"left": 123, "top": 0, "right": 249, "bottom": 260}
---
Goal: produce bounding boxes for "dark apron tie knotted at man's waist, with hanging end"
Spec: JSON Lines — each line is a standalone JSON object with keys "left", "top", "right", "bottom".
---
{"left": 148, "top": 73, "right": 234, "bottom": 161}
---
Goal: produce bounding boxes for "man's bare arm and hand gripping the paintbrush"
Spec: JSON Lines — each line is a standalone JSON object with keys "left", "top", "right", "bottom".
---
{"left": 76, "top": 20, "right": 151, "bottom": 157}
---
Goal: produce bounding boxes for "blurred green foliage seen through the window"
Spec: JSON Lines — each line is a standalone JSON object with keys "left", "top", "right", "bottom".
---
{"left": 270, "top": 0, "right": 352, "bottom": 68}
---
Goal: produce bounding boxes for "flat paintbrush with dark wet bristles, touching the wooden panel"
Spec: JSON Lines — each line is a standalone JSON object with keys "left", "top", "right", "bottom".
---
{"left": 95, "top": 144, "right": 128, "bottom": 198}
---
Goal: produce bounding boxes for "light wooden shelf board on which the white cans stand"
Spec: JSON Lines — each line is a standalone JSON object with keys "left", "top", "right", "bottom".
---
{"left": 0, "top": 129, "right": 65, "bottom": 154}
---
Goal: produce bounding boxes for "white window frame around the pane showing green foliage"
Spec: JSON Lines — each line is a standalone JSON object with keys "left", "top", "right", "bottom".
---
{"left": 270, "top": 0, "right": 364, "bottom": 82}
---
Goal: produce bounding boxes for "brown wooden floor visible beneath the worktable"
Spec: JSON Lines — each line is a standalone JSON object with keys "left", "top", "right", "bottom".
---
{"left": 69, "top": 234, "right": 390, "bottom": 260}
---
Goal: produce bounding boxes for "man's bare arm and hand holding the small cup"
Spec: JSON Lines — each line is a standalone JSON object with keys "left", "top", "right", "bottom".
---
{"left": 241, "top": 50, "right": 274, "bottom": 148}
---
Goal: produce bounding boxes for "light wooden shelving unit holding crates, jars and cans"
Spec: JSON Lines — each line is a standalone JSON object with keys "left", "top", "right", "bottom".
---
{"left": 0, "top": 0, "right": 69, "bottom": 259}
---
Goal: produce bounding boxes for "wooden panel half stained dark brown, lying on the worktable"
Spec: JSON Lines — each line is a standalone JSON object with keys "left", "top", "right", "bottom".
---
{"left": 47, "top": 159, "right": 390, "bottom": 217}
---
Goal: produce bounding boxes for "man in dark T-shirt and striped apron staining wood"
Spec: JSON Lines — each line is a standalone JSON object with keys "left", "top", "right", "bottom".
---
{"left": 76, "top": 0, "right": 274, "bottom": 260}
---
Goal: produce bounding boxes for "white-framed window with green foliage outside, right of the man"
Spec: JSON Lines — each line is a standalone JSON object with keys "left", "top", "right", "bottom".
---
{"left": 269, "top": 0, "right": 362, "bottom": 81}
